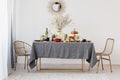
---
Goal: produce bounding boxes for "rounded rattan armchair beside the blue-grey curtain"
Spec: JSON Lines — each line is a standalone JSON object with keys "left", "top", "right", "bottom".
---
{"left": 14, "top": 41, "right": 31, "bottom": 71}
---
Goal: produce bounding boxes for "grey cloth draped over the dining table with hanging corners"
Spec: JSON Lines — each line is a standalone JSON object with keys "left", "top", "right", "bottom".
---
{"left": 29, "top": 42, "right": 97, "bottom": 69}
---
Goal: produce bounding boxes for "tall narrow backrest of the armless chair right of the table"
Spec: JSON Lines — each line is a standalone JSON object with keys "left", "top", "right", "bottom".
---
{"left": 103, "top": 38, "right": 114, "bottom": 54}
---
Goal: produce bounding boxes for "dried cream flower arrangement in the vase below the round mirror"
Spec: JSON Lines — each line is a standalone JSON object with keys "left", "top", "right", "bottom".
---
{"left": 52, "top": 15, "right": 72, "bottom": 29}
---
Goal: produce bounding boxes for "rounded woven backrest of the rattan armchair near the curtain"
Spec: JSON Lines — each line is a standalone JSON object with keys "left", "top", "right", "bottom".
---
{"left": 14, "top": 41, "right": 31, "bottom": 55}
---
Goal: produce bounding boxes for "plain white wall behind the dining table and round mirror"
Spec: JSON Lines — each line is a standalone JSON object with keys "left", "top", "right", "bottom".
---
{"left": 16, "top": 0, "right": 120, "bottom": 64}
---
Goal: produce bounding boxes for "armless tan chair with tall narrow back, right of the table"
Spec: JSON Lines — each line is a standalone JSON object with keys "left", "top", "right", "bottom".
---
{"left": 96, "top": 38, "right": 114, "bottom": 73}
